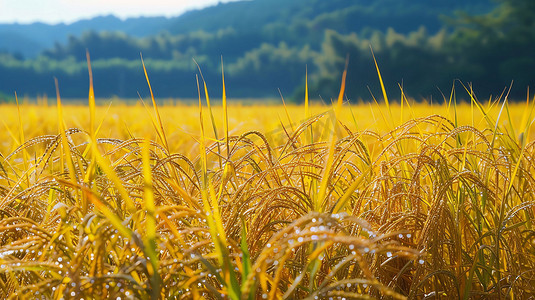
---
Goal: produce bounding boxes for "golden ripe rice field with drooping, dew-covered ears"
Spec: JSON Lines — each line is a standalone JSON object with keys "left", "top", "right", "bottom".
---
{"left": 0, "top": 68, "right": 535, "bottom": 299}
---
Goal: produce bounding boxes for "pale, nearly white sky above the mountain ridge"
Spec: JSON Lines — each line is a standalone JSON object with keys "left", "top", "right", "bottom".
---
{"left": 0, "top": 0, "right": 239, "bottom": 24}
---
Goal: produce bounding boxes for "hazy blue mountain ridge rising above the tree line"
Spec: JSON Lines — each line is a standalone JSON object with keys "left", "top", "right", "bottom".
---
{"left": 0, "top": 0, "right": 494, "bottom": 58}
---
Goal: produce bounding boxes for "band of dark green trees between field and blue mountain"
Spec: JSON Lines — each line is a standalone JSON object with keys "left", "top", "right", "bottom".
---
{"left": 0, "top": 0, "right": 535, "bottom": 102}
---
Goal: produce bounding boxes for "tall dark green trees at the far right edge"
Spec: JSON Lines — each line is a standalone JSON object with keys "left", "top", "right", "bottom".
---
{"left": 449, "top": 0, "right": 535, "bottom": 97}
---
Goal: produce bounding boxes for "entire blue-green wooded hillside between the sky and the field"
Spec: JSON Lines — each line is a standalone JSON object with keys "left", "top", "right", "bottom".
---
{"left": 0, "top": 0, "right": 534, "bottom": 101}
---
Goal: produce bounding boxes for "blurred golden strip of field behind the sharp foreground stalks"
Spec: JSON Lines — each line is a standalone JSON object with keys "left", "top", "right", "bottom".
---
{"left": 0, "top": 99, "right": 535, "bottom": 157}
